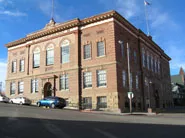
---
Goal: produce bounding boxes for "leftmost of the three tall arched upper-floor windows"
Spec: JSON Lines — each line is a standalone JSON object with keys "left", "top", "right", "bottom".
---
{"left": 33, "top": 47, "right": 40, "bottom": 68}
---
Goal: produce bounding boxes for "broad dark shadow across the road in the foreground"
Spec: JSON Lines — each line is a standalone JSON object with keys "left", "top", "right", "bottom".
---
{"left": 0, "top": 117, "right": 185, "bottom": 138}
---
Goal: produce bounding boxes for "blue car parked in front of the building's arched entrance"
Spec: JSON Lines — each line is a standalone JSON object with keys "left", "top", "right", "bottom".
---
{"left": 37, "top": 96, "right": 66, "bottom": 108}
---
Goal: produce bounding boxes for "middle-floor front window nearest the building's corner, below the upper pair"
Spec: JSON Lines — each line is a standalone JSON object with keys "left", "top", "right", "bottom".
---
{"left": 97, "top": 70, "right": 107, "bottom": 87}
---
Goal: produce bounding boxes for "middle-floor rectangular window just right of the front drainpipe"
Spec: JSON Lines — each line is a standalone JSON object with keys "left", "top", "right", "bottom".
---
{"left": 83, "top": 72, "right": 92, "bottom": 88}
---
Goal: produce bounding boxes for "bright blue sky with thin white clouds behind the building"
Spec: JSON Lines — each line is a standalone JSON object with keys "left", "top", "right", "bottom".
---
{"left": 0, "top": 0, "right": 185, "bottom": 87}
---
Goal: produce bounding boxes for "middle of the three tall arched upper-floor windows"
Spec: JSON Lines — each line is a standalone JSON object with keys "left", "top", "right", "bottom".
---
{"left": 46, "top": 44, "right": 54, "bottom": 65}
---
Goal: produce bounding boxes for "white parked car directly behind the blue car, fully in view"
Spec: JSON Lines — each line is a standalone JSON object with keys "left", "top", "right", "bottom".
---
{"left": 10, "top": 97, "right": 31, "bottom": 105}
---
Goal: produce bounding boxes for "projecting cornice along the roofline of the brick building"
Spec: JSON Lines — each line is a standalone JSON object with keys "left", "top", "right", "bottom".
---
{"left": 5, "top": 10, "right": 171, "bottom": 60}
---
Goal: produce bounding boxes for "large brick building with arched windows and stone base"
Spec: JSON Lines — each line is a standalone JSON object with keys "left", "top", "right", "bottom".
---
{"left": 6, "top": 11, "right": 172, "bottom": 112}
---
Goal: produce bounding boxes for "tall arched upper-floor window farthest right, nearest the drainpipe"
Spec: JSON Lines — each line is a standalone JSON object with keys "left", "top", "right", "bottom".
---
{"left": 61, "top": 40, "right": 70, "bottom": 63}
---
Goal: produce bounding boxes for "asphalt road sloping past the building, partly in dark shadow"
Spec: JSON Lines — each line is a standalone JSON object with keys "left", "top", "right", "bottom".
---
{"left": 0, "top": 103, "right": 185, "bottom": 138}
